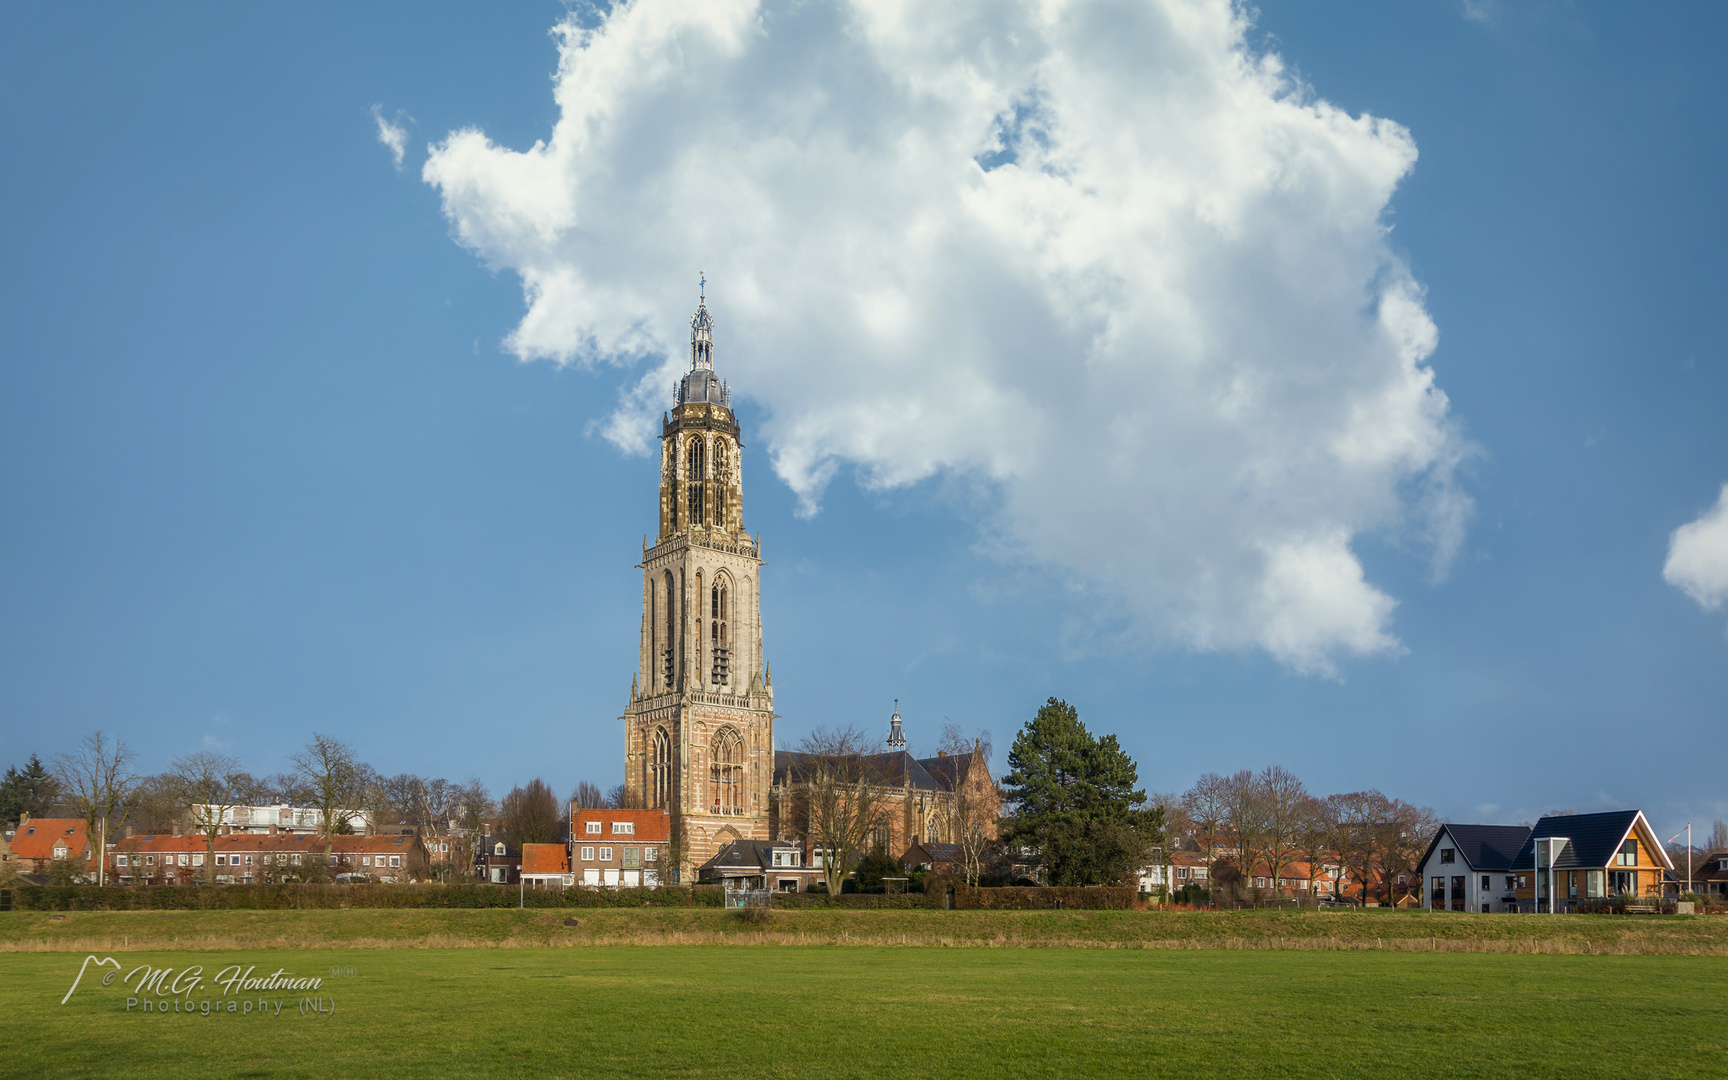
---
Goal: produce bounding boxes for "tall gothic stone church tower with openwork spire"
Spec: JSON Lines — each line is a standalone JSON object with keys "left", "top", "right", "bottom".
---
{"left": 622, "top": 281, "right": 774, "bottom": 883}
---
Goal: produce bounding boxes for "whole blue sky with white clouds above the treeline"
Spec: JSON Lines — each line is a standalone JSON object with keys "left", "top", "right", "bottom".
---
{"left": 0, "top": 2, "right": 1728, "bottom": 835}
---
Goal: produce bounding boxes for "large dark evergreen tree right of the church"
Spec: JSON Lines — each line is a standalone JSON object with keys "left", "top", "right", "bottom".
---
{"left": 1002, "top": 698, "right": 1163, "bottom": 885}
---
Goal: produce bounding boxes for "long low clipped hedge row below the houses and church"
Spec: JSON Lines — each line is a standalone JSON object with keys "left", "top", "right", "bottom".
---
{"left": 14, "top": 878, "right": 1135, "bottom": 911}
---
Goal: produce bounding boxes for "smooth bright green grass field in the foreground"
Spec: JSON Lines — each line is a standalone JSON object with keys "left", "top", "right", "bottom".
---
{"left": 0, "top": 945, "right": 1728, "bottom": 1080}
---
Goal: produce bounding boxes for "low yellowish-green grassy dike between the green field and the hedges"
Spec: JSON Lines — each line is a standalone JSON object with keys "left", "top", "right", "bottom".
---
{"left": 0, "top": 907, "right": 1728, "bottom": 956}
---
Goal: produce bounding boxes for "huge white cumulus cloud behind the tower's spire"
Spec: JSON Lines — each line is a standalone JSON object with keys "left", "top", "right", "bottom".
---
{"left": 423, "top": 0, "right": 1471, "bottom": 674}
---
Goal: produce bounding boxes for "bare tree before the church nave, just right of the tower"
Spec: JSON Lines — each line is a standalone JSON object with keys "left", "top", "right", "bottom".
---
{"left": 788, "top": 727, "right": 883, "bottom": 897}
